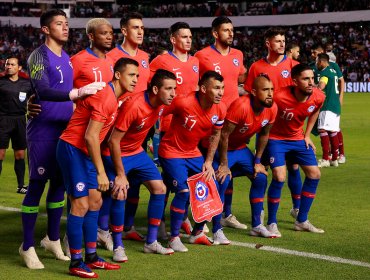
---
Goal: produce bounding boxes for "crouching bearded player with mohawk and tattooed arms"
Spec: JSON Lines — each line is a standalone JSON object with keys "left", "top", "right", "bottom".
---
{"left": 212, "top": 74, "right": 277, "bottom": 238}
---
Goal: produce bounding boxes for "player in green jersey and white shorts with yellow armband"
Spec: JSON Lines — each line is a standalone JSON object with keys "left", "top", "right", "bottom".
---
{"left": 316, "top": 53, "right": 341, "bottom": 167}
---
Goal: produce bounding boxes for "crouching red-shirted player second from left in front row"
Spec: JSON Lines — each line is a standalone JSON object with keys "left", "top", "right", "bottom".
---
{"left": 103, "top": 69, "right": 176, "bottom": 262}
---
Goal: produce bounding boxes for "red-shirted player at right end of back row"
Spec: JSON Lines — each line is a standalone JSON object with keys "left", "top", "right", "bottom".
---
{"left": 244, "top": 27, "right": 302, "bottom": 222}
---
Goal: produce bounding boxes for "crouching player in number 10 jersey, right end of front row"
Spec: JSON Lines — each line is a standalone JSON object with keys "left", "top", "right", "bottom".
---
{"left": 266, "top": 64, "right": 325, "bottom": 237}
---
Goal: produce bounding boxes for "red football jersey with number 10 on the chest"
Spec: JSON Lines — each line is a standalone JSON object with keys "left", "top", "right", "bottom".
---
{"left": 269, "top": 87, "right": 325, "bottom": 140}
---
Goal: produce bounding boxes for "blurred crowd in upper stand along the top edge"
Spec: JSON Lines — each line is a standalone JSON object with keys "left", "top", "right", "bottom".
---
{"left": 0, "top": 0, "right": 370, "bottom": 18}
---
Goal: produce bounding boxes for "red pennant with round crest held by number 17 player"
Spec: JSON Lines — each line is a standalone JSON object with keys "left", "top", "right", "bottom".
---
{"left": 187, "top": 173, "right": 223, "bottom": 223}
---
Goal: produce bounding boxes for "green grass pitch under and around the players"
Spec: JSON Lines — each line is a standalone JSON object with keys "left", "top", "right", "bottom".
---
{"left": 0, "top": 93, "right": 370, "bottom": 280}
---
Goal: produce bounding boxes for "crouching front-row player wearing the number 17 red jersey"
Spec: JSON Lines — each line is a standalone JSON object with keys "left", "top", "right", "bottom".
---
{"left": 159, "top": 71, "right": 226, "bottom": 252}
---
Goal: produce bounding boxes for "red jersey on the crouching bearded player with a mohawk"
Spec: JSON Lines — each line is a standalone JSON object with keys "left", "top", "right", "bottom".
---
{"left": 226, "top": 94, "right": 277, "bottom": 150}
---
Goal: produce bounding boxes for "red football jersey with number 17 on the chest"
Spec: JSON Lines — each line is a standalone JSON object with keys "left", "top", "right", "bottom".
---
{"left": 158, "top": 94, "right": 226, "bottom": 158}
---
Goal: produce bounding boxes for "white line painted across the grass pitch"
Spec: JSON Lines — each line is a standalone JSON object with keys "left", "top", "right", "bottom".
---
{"left": 0, "top": 205, "right": 370, "bottom": 268}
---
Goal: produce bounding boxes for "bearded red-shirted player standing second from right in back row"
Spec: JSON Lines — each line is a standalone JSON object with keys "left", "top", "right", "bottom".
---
{"left": 195, "top": 16, "right": 247, "bottom": 229}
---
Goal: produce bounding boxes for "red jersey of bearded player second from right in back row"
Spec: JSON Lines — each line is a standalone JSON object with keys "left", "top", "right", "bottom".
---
{"left": 195, "top": 45, "right": 246, "bottom": 107}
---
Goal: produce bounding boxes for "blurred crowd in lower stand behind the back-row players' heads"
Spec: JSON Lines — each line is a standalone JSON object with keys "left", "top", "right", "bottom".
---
{"left": 0, "top": 19, "right": 370, "bottom": 81}
